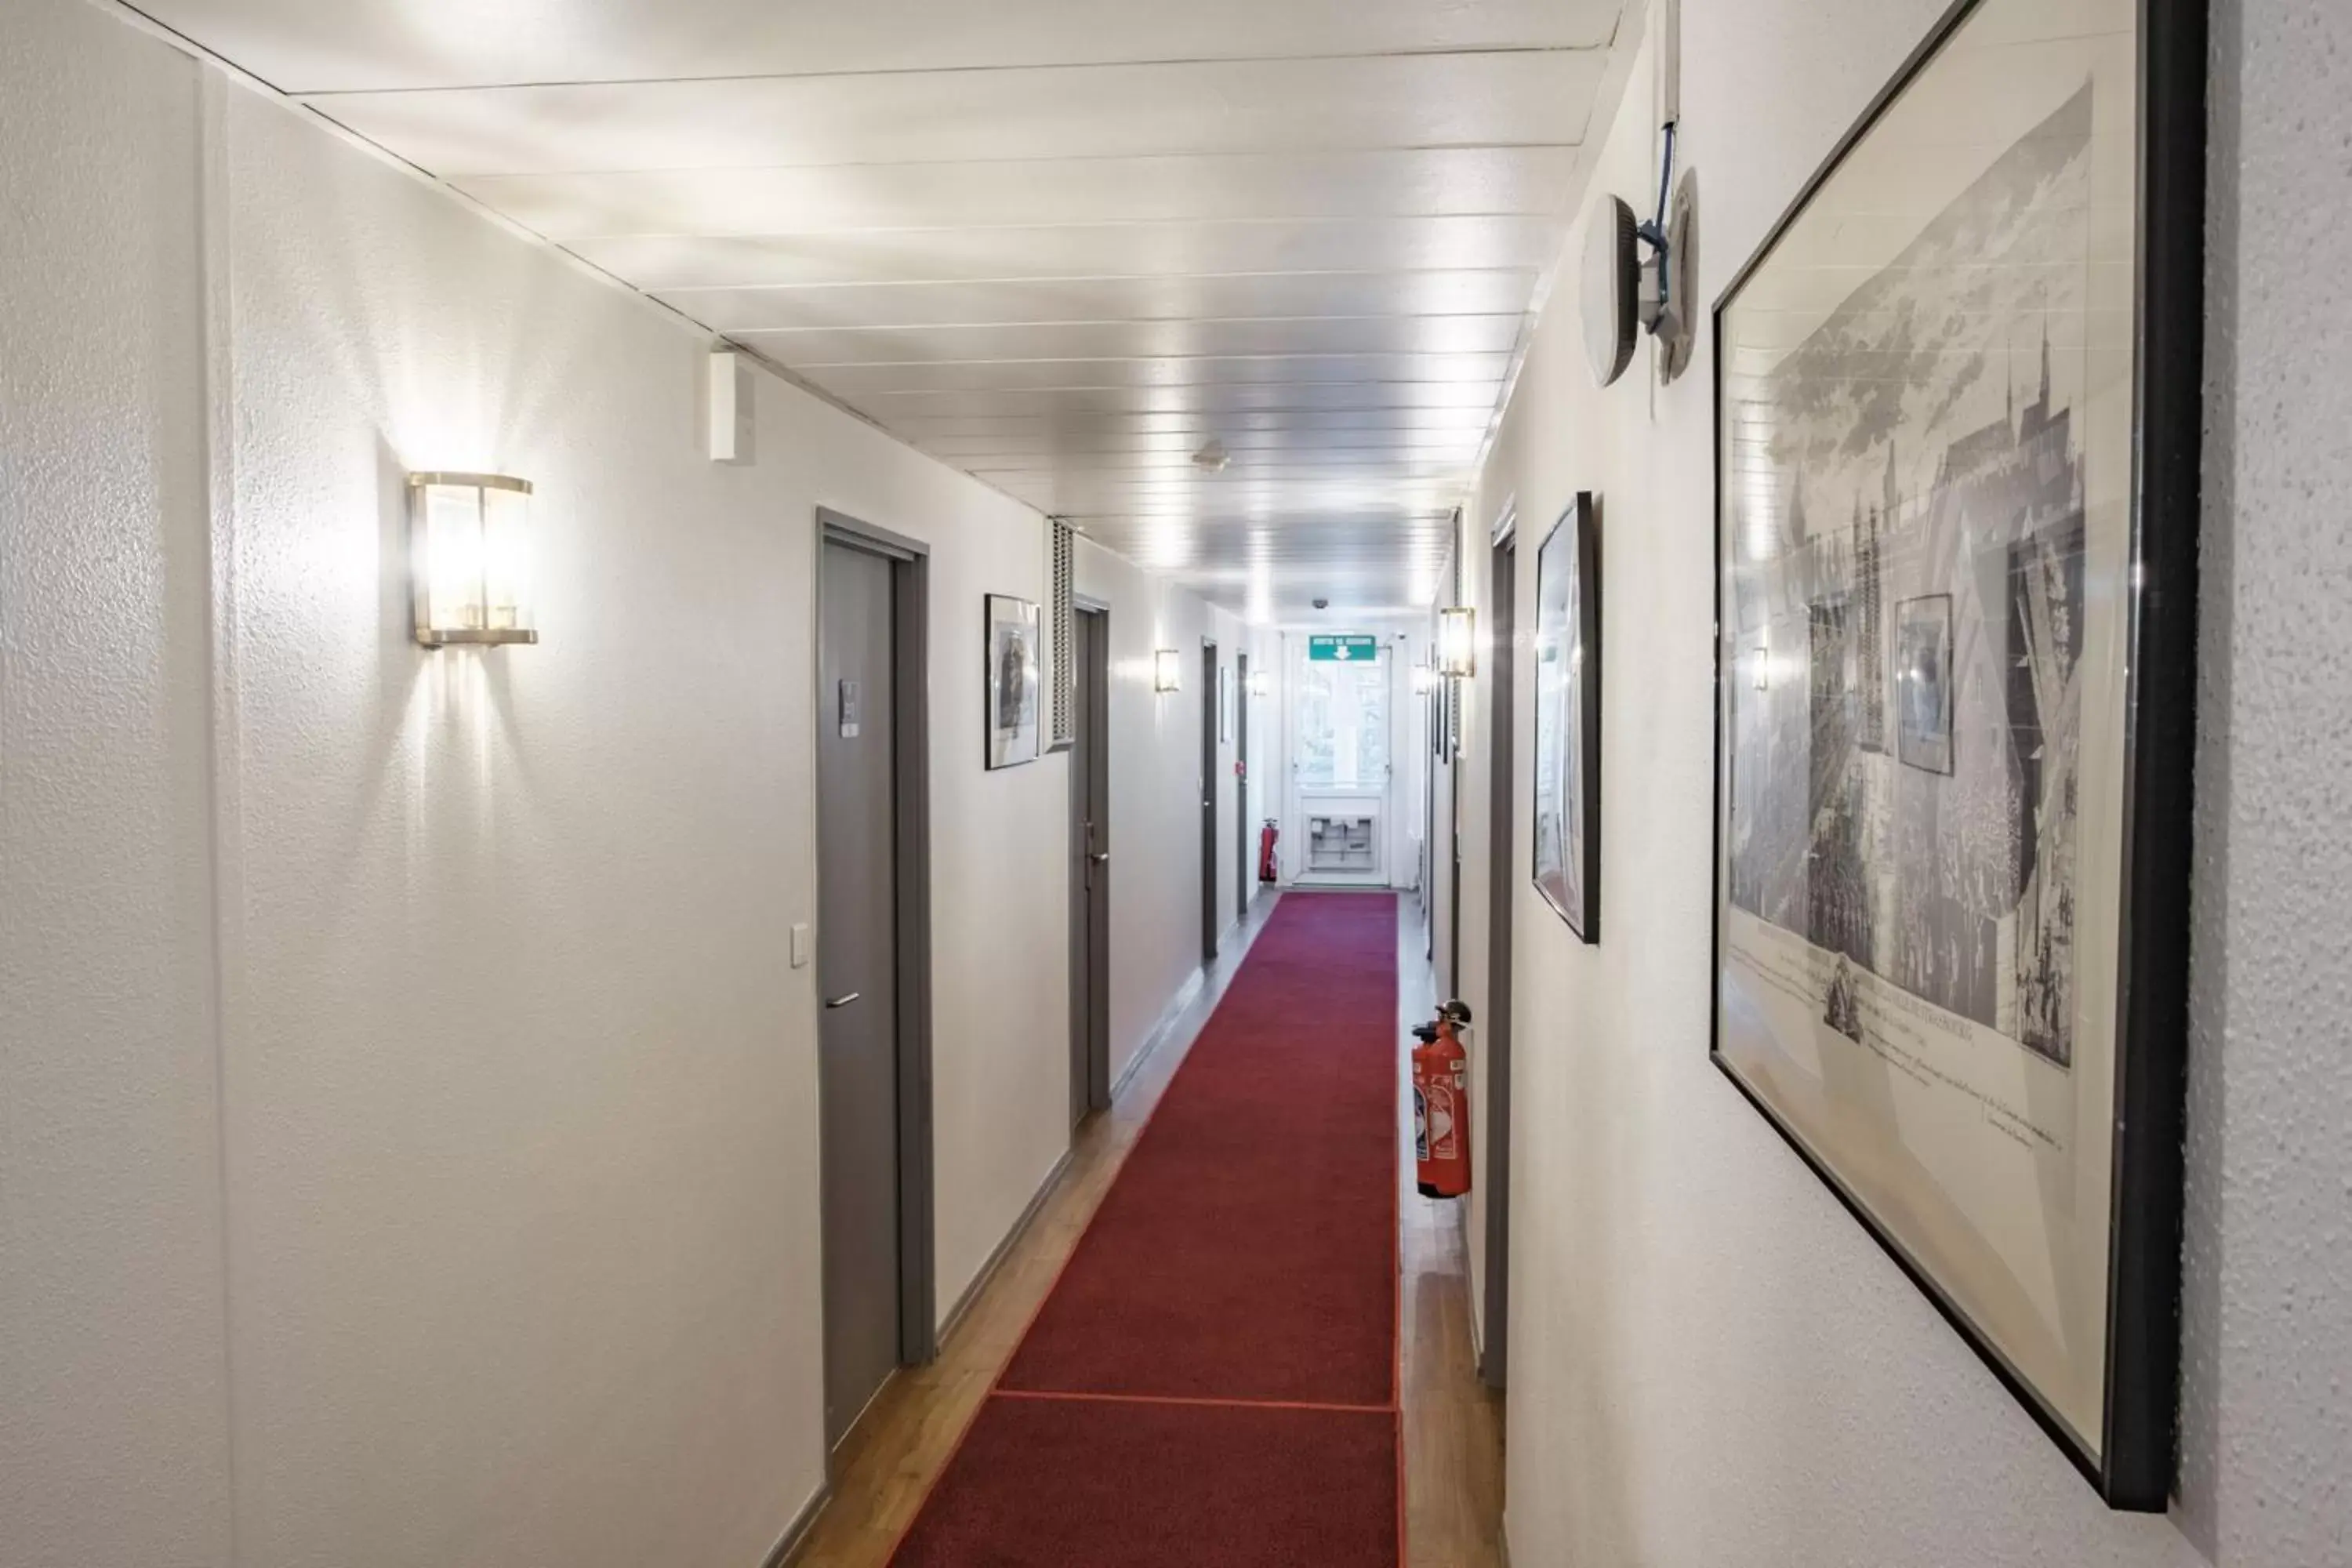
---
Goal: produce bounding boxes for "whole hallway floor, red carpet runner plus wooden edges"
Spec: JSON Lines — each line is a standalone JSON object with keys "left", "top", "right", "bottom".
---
{"left": 793, "top": 893, "right": 1501, "bottom": 1568}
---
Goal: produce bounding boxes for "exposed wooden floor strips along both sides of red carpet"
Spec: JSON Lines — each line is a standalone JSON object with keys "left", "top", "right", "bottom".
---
{"left": 786, "top": 893, "right": 1503, "bottom": 1568}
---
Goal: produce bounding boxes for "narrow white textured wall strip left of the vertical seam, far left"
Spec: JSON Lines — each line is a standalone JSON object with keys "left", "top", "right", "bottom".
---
{"left": 0, "top": 5, "right": 228, "bottom": 1568}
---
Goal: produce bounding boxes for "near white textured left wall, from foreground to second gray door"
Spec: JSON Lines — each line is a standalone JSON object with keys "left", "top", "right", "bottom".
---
{"left": 0, "top": 0, "right": 1101, "bottom": 1568}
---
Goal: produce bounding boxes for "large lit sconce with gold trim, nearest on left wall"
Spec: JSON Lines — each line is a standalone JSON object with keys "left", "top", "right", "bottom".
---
{"left": 409, "top": 473, "right": 539, "bottom": 649}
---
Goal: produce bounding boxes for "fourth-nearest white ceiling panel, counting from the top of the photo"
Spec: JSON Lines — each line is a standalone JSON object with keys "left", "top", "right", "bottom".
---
{"left": 569, "top": 216, "right": 1566, "bottom": 288}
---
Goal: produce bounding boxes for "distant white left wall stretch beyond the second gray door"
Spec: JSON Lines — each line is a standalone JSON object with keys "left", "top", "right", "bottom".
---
{"left": 1077, "top": 539, "right": 1275, "bottom": 1083}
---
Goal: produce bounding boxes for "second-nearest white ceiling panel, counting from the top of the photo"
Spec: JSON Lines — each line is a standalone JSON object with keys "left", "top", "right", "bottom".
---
{"left": 306, "top": 52, "right": 1602, "bottom": 179}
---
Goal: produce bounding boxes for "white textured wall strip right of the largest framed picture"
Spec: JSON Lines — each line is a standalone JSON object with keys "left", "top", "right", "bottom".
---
{"left": 2180, "top": 0, "right": 2352, "bottom": 1568}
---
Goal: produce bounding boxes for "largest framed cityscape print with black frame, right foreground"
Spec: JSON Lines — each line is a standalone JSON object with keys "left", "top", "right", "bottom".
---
{"left": 1712, "top": 0, "right": 2206, "bottom": 1509}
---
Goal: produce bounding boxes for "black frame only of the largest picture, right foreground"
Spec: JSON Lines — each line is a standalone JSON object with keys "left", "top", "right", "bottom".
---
{"left": 1708, "top": 0, "right": 2209, "bottom": 1512}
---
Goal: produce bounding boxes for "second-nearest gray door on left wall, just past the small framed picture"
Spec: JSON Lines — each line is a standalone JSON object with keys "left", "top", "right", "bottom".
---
{"left": 1070, "top": 609, "right": 1110, "bottom": 1126}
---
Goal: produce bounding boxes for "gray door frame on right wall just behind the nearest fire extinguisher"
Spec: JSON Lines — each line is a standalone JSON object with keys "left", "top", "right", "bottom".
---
{"left": 1477, "top": 508, "right": 1519, "bottom": 1389}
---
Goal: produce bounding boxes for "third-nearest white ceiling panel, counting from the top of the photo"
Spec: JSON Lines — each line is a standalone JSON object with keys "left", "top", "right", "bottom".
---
{"left": 454, "top": 146, "right": 1576, "bottom": 240}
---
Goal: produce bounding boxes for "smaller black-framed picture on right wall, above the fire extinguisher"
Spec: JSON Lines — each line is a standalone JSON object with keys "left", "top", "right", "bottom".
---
{"left": 1531, "top": 492, "right": 1602, "bottom": 942}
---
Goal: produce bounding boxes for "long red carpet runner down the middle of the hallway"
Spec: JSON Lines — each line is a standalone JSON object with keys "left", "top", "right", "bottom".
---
{"left": 891, "top": 893, "right": 1402, "bottom": 1568}
